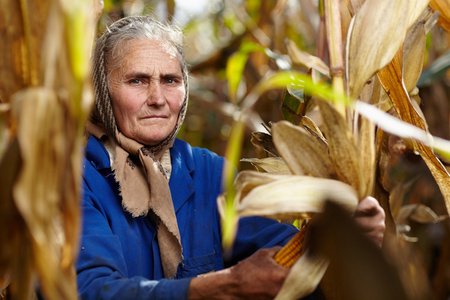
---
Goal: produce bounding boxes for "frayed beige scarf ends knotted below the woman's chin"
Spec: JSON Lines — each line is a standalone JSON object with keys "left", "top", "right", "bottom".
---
{"left": 86, "top": 122, "right": 182, "bottom": 278}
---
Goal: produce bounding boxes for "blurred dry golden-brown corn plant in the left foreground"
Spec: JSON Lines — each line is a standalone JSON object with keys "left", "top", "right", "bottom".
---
{"left": 0, "top": 0, "right": 99, "bottom": 299}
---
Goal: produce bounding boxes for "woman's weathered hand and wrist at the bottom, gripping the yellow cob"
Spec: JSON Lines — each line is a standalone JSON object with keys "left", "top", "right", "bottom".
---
{"left": 189, "top": 247, "right": 290, "bottom": 299}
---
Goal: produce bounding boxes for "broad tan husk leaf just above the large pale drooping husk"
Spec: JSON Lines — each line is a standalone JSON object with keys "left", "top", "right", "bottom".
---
{"left": 272, "top": 121, "right": 335, "bottom": 178}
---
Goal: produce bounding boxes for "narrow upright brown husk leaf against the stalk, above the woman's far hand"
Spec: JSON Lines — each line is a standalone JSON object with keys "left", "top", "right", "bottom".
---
{"left": 316, "top": 101, "right": 367, "bottom": 199}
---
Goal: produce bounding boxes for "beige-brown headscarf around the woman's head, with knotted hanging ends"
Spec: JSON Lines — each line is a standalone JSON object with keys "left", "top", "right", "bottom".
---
{"left": 86, "top": 17, "right": 188, "bottom": 278}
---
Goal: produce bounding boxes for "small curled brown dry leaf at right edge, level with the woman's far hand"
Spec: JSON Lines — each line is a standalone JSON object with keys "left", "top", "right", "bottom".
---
{"left": 395, "top": 204, "right": 448, "bottom": 224}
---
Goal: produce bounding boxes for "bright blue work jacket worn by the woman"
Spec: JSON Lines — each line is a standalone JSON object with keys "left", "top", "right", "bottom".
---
{"left": 77, "top": 136, "right": 297, "bottom": 299}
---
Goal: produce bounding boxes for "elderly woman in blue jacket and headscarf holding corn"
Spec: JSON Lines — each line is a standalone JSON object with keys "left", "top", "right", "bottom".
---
{"left": 77, "top": 17, "right": 384, "bottom": 299}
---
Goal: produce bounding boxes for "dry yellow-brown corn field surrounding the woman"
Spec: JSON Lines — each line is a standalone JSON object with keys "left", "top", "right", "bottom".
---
{"left": 0, "top": 0, "right": 450, "bottom": 299}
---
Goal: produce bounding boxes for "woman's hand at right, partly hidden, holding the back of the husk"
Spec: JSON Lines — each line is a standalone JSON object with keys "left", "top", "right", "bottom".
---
{"left": 355, "top": 197, "right": 386, "bottom": 247}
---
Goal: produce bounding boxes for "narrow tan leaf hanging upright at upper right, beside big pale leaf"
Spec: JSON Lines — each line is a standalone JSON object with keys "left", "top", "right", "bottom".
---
{"left": 403, "top": 22, "right": 426, "bottom": 94}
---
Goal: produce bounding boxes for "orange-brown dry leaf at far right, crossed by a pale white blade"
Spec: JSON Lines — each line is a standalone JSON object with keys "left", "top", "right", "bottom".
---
{"left": 378, "top": 51, "right": 450, "bottom": 218}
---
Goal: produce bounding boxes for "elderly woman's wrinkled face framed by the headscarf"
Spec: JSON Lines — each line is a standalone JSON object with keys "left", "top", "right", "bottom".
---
{"left": 109, "top": 40, "right": 186, "bottom": 146}
